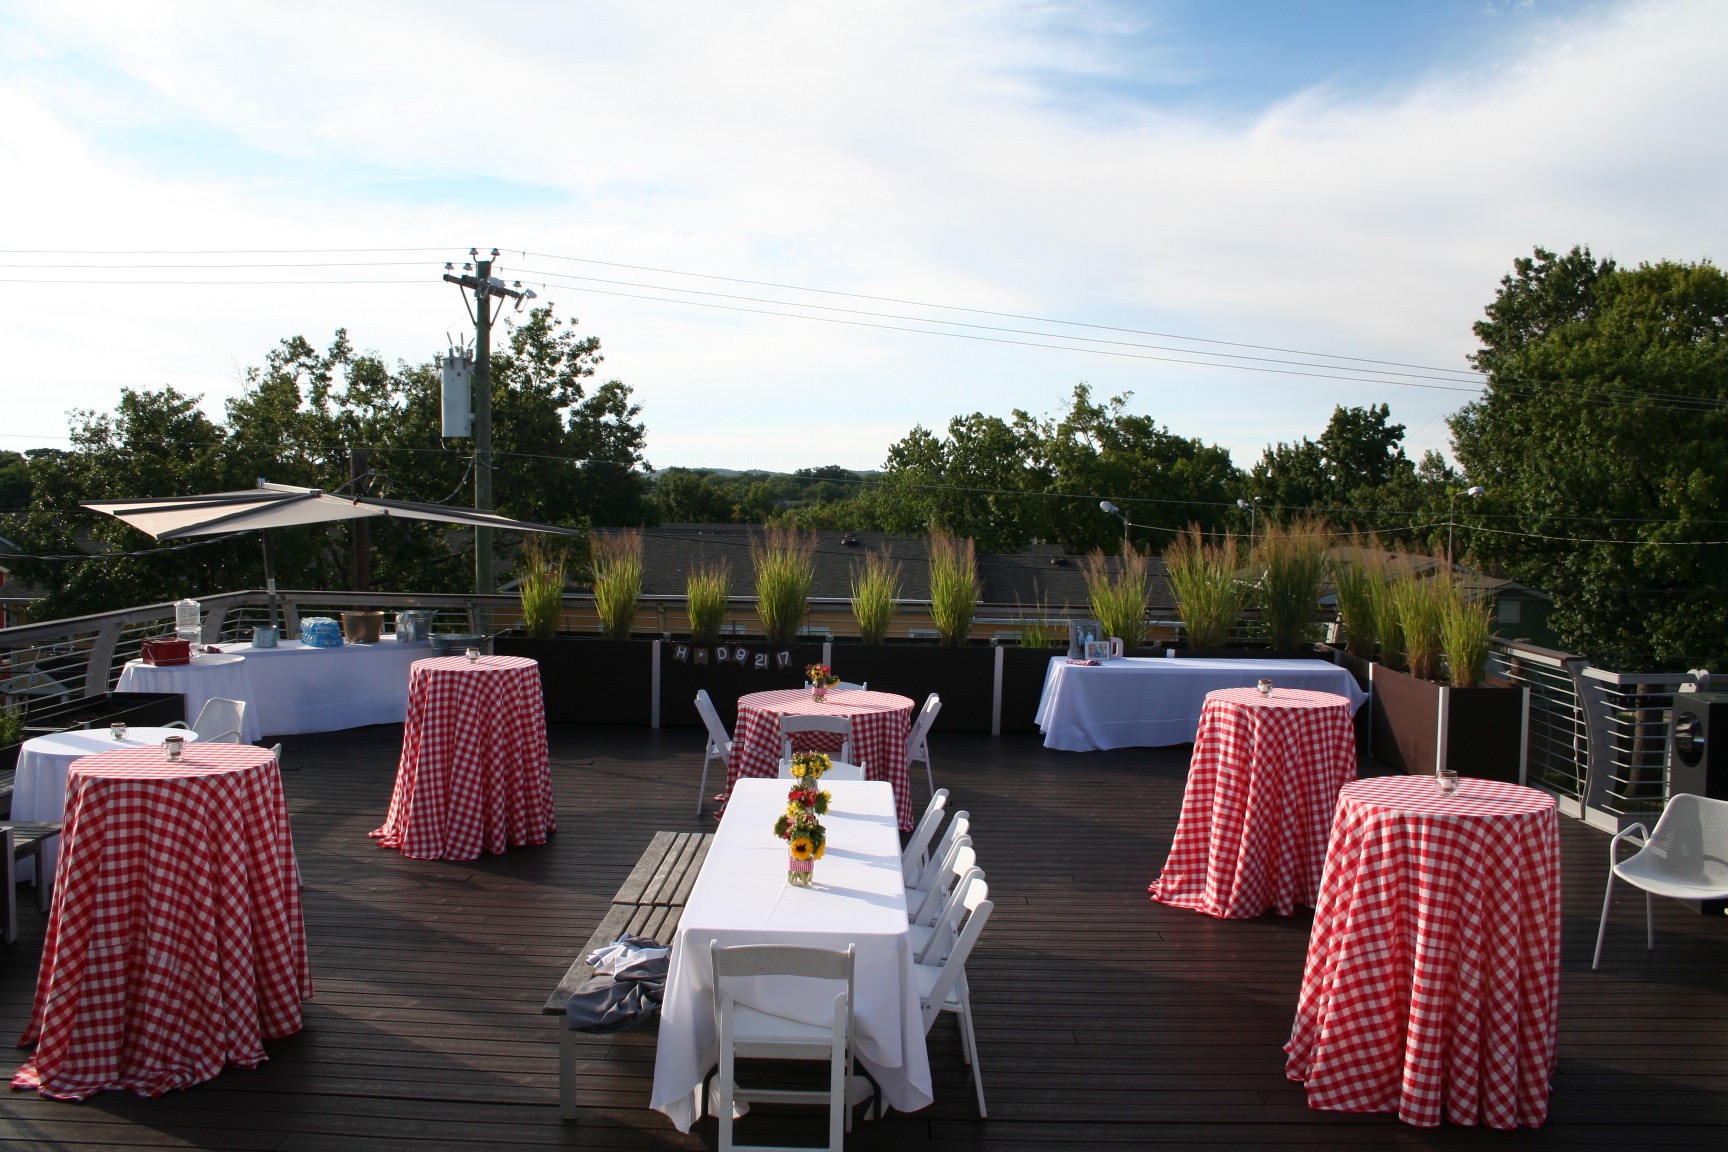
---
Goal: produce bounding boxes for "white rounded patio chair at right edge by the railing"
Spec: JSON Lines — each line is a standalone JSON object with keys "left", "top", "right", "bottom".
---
{"left": 1590, "top": 793, "right": 1728, "bottom": 969}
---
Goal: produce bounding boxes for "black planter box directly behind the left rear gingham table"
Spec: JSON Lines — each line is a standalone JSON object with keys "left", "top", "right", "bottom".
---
{"left": 492, "top": 636, "right": 653, "bottom": 725}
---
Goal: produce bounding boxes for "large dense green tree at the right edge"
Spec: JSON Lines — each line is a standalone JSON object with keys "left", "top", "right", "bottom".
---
{"left": 1452, "top": 247, "right": 1728, "bottom": 665}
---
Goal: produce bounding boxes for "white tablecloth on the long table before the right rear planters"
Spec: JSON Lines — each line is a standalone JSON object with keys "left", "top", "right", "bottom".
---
{"left": 1037, "top": 656, "right": 1369, "bottom": 751}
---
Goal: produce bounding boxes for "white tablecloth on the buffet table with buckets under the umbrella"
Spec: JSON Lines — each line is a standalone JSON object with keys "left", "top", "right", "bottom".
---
{"left": 119, "top": 636, "right": 432, "bottom": 744}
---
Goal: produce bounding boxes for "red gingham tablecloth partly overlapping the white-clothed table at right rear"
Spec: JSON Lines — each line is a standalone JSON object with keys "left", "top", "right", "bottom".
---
{"left": 1149, "top": 687, "right": 1356, "bottom": 919}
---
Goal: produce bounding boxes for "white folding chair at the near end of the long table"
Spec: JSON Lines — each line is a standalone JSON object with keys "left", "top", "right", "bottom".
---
{"left": 708, "top": 941, "right": 857, "bottom": 1152}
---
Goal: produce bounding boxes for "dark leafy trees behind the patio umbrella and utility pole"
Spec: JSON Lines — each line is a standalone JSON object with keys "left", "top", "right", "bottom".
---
{"left": 0, "top": 307, "right": 651, "bottom": 617}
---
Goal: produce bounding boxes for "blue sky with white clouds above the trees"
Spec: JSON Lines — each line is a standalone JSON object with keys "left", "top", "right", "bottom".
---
{"left": 0, "top": 0, "right": 1728, "bottom": 468}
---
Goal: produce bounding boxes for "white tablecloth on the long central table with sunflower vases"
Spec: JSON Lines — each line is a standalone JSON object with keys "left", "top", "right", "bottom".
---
{"left": 653, "top": 779, "right": 933, "bottom": 1131}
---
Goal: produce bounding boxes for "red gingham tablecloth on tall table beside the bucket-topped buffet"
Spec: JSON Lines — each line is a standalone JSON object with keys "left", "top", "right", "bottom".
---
{"left": 372, "top": 656, "right": 558, "bottom": 860}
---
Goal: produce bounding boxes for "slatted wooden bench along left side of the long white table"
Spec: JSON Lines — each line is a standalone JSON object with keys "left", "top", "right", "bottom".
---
{"left": 541, "top": 832, "right": 714, "bottom": 1119}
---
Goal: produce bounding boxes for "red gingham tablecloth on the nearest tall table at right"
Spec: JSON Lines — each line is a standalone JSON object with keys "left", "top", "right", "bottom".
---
{"left": 1284, "top": 775, "right": 1560, "bottom": 1128}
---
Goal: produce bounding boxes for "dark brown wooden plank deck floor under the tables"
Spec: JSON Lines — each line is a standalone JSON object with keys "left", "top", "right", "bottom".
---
{"left": 0, "top": 727, "right": 1728, "bottom": 1152}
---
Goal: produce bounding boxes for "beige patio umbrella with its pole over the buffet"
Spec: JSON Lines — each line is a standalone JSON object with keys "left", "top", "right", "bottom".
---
{"left": 83, "top": 480, "right": 582, "bottom": 625}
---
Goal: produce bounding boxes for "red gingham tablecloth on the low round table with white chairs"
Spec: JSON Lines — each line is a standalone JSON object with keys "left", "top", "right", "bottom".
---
{"left": 726, "top": 687, "right": 914, "bottom": 832}
